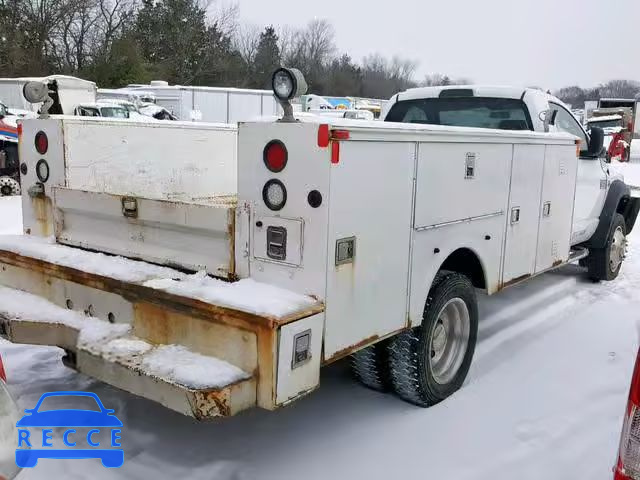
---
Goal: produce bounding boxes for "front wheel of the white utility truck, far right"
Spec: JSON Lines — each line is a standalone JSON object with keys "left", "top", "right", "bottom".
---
{"left": 586, "top": 213, "right": 627, "bottom": 281}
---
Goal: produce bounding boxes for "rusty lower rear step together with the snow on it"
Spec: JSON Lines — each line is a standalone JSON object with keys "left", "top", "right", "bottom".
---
{"left": 0, "top": 287, "right": 255, "bottom": 419}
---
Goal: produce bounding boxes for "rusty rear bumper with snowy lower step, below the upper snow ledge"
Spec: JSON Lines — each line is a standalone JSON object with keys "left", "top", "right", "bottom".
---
{"left": 0, "top": 237, "right": 323, "bottom": 420}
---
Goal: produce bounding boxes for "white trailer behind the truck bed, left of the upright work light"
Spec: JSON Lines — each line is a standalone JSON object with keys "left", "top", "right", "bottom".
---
{"left": 126, "top": 82, "right": 280, "bottom": 123}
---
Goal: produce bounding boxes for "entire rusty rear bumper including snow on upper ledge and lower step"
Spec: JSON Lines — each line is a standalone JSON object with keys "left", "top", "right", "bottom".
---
{"left": 0, "top": 237, "right": 324, "bottom": 419}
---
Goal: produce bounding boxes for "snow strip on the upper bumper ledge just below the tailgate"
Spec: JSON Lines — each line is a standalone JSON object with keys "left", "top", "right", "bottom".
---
{"left": 0, "top": 235, "right": 317, "bottom": 318}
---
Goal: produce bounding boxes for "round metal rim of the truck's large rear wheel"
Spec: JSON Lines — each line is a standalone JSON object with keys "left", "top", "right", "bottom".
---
{"left": 429, "top": 298, "right": 471, "bottom": 385}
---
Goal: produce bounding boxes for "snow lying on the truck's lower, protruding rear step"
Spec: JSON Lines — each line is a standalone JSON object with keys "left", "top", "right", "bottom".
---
{"left": 0, "top": 287, "right": 250, "bottom": 389}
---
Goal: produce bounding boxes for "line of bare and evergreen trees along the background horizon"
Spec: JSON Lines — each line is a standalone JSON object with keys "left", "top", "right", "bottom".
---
{"left": 0, "top": 0, "right": 640, "bottom": 101}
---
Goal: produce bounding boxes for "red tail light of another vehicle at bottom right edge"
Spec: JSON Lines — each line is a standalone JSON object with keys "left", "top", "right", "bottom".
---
{"left": 614, "top": 352, "right": 640, "bottom": 480}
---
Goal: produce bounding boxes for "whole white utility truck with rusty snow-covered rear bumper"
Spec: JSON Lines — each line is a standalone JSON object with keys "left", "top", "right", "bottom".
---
{"left": 0, "top": 69, "right": 639, "bottom": 419}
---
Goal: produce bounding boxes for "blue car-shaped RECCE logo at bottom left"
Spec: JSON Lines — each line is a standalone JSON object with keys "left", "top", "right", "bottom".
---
{"left": 16, "top": 392, "right": 124, "bottom": 468}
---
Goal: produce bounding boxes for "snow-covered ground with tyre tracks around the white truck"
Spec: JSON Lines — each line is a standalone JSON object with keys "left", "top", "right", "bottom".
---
{"left": 0, "top": 199, "right": 640, "bottom": 480}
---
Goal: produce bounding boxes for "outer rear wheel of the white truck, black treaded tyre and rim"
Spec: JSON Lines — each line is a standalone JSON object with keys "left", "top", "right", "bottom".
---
{"left": 389, "top": 272, "right": 478, "bottom": 407}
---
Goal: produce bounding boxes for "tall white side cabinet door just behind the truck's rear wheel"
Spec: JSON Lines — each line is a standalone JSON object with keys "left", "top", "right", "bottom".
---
{"left": 324, "top": 142, "right": 416, "bottom": 359}
